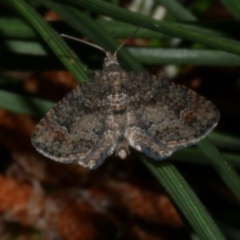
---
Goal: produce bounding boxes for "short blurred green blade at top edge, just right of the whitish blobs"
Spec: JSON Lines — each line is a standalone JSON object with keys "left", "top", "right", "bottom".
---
{"left": 155, "top": 0, "right": 197, "bottom": 21}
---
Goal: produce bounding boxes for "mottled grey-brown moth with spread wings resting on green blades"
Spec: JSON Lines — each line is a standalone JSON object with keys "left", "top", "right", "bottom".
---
{"left": 32, "top": 38, "right": 220, "bottom": 169}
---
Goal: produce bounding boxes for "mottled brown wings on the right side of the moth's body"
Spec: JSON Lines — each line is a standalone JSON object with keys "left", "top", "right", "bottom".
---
{"left": 126, "top": 72, "right": 220, "bottom": 160}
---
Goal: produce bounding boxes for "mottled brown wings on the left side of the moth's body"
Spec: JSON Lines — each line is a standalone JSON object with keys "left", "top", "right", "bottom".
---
{"left": 32, "top": 77, "right": 116, "bottom": 168}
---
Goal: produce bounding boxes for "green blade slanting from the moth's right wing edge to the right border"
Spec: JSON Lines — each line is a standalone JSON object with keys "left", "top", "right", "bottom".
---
{"left": 197, "top": 137, "right": 240, "bottom": 200}
